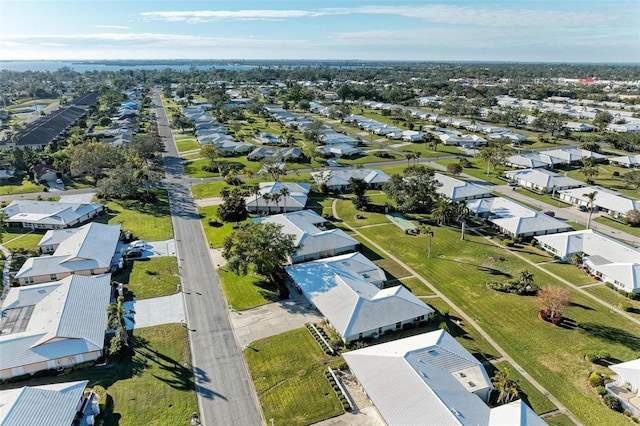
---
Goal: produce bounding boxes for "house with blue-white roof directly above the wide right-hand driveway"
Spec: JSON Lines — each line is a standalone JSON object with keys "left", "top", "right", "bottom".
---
{"left": 285, "top": 253, "right": 434, "bottom": 342}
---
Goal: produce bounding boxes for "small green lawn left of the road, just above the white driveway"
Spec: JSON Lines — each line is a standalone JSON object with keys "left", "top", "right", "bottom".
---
{"left": 113, "top": 256, "right": 180, "bottom": 300}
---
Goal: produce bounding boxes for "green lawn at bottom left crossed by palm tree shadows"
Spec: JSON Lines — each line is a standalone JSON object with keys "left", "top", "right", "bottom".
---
{"left": 0, "top": 324, "right": 198, "bottom": 426}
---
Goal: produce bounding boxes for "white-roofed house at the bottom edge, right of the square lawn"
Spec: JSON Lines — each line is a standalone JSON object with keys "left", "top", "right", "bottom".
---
{"left": 343, "top": 330, "right": 546, "bottom": 426}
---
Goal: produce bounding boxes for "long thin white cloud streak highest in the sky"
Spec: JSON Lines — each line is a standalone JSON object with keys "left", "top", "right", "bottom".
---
{"left": 141, "top": 4, "right": 632, "bottom": 27}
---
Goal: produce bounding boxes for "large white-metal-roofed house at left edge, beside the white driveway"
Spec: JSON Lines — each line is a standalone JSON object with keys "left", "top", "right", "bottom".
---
{"left": 0, "top": 274, "right": 111, "bottom": 380}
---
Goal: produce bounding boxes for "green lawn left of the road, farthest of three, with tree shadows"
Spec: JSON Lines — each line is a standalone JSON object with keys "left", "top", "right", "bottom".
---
{"left": 97, "top": 189, "right": 173, "bottom": 241}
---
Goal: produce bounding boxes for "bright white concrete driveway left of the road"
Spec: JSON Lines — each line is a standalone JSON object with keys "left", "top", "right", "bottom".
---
{"left": 122, "top": 293, "right": 184, "bottom": 330}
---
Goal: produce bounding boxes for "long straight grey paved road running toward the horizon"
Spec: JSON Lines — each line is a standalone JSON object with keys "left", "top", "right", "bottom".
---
{"left": 153, "top": 93, "right": 264, "bottom": 426}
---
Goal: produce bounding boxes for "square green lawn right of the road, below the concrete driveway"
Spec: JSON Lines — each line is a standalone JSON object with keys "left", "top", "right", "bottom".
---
{"left": 244, "top": 328, "right": 344, "bottom": 426}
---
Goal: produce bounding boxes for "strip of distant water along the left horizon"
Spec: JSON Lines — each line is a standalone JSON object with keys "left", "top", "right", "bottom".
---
{"left": 0, "top": 61, "right": 256, "bottom": 72}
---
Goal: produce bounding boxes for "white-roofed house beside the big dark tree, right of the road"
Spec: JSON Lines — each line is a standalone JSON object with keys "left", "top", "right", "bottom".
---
{"left": 253, "top": 210, "right": 360, "bottom": 264}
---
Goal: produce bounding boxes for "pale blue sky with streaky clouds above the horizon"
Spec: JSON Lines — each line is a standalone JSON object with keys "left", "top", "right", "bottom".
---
{"left": 0, "top": 0, "right": 640, "bottom": 63}
